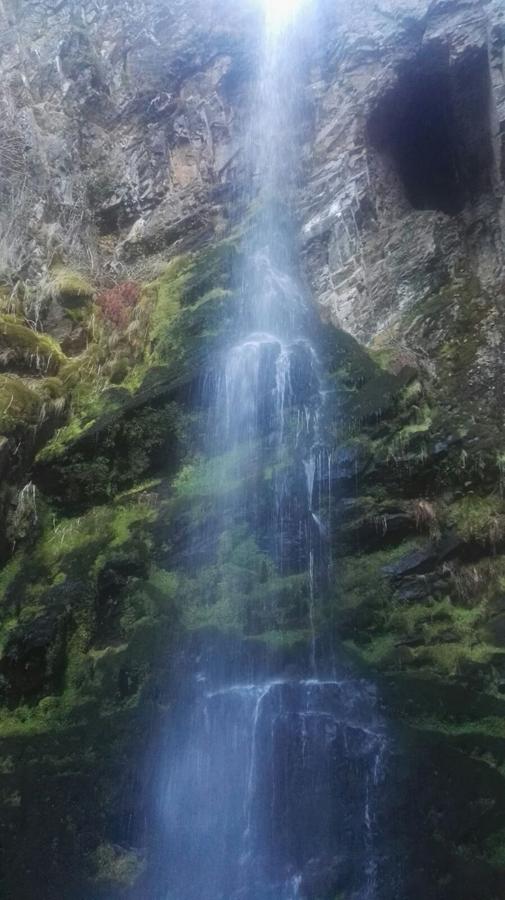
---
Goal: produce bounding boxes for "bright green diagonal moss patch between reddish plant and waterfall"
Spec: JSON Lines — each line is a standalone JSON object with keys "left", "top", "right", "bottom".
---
{"left": 34, "top": 248, "right": 233, "bottom": 495}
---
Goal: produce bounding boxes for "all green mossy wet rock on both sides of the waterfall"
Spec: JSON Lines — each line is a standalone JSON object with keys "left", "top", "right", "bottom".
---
{"left": 0, "top": 248, "right": 505, "bottom": 900}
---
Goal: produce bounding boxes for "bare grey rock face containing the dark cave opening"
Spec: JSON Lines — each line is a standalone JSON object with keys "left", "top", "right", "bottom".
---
{"left": 301, "top": 2, "right": 505, "bottom": 340}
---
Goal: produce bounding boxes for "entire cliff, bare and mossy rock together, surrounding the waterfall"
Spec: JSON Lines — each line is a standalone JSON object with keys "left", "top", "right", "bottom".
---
{"left": 0, "top": 0, "right": 505, "bottom": 900}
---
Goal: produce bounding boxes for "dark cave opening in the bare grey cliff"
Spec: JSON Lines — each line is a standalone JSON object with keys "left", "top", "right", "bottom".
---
{"left": 368, "top": 47, "right": 493, "bottom": 215}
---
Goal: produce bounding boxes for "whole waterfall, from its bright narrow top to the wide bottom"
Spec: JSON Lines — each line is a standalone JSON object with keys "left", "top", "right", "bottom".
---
{"left": 144, "top": 1, "right": 388, "bottom": 900}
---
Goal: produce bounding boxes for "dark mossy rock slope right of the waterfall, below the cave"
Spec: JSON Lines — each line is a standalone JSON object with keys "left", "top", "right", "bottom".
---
{"left": 330, "top": 272, "right": 505, "bottom": 900}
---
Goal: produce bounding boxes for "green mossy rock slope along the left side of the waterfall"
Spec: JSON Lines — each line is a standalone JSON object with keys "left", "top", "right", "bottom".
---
{"left": 0, "top": 236, "right": 248, "bottom": 900}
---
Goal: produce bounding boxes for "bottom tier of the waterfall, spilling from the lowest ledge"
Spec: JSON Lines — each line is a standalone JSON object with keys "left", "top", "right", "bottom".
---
{"left": 158, "top": 679, "right": 387, "bottom": 900}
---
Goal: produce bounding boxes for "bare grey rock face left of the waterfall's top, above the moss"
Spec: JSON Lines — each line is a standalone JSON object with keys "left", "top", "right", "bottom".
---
{"left": 2, "top": 0, "right": 246, "bottom": 277}
